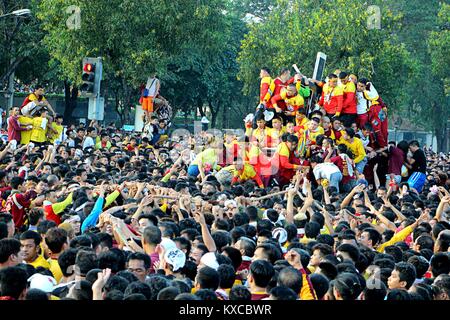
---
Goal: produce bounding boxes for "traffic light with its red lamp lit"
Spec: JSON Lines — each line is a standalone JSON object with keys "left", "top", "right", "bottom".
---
{"left": 80, "top": 58, "right": 103, "bottom": 97}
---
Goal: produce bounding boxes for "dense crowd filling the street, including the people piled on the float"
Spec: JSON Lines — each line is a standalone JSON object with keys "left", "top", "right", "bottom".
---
{"left": 0, "top": 68, "right": 450, "bottom": 301}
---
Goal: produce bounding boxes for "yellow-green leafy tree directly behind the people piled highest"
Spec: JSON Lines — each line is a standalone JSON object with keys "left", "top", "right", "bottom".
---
{"left": 238, "top": 0, "right": 412, "bottom": 110}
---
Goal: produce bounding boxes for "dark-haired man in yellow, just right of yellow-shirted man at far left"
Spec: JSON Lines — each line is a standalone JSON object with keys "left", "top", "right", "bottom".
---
{"left": 45, "top": 228, "right": 68, "bottom": 283}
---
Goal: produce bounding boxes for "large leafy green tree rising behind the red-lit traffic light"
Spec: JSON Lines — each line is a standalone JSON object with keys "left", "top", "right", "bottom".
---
{"left": 38, "top": 0, "right": 230, "bottom": 122}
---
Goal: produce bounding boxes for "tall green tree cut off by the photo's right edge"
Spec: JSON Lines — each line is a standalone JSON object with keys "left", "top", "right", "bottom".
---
{"left": 386, "top": 0, "right": 450, "bottom": 151}
